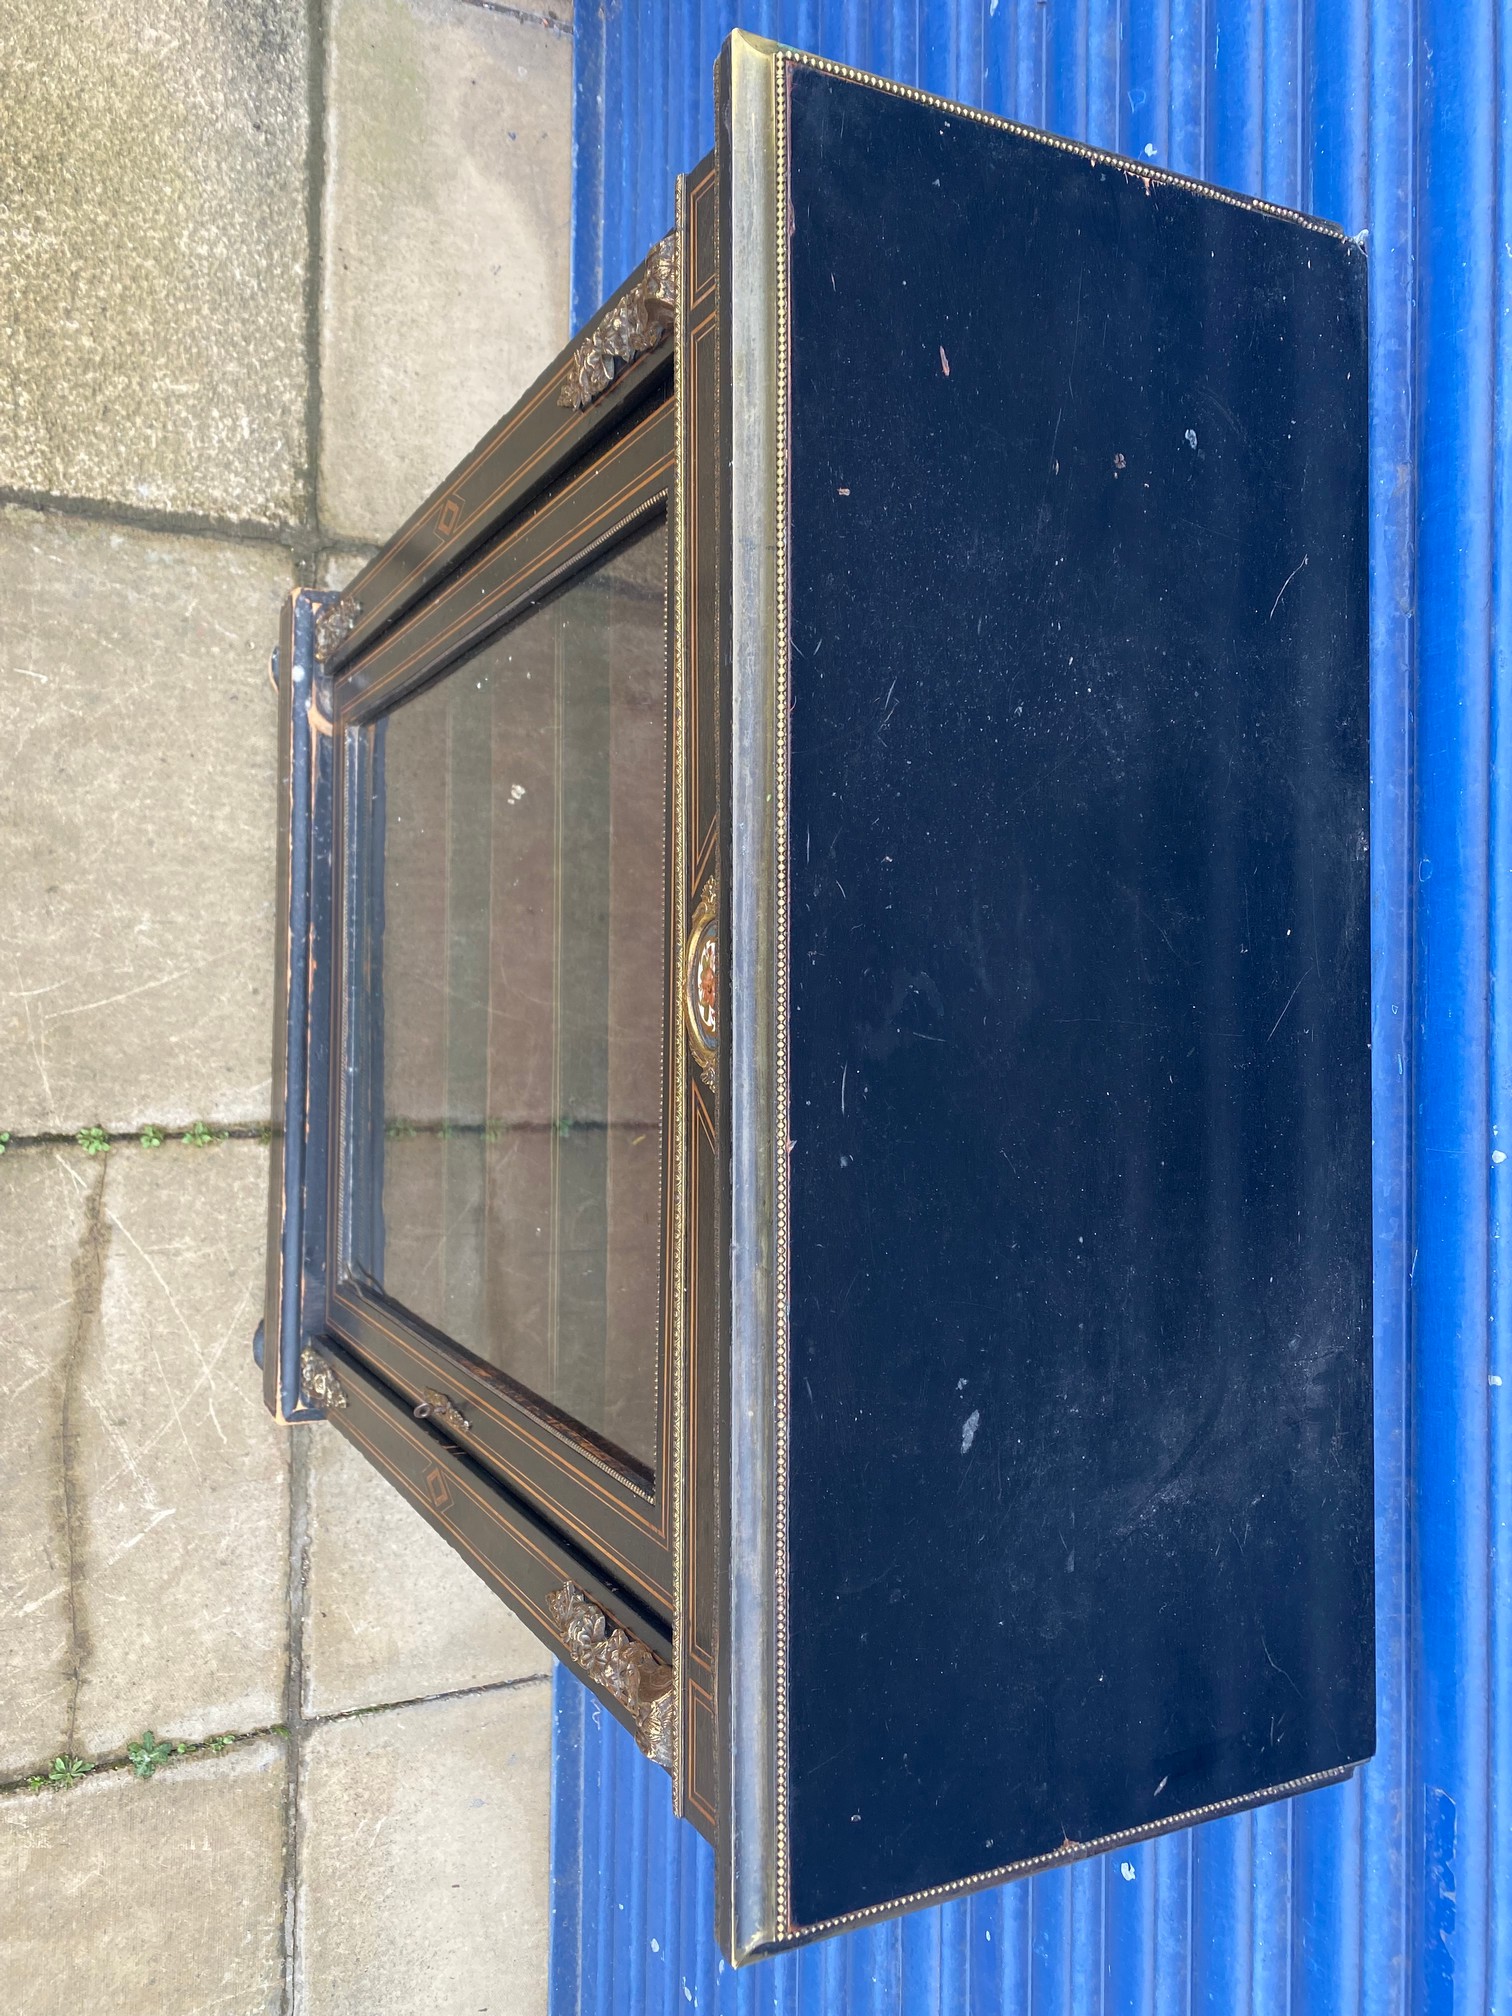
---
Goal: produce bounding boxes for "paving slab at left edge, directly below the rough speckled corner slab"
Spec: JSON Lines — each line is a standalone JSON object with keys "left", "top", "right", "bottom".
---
{"left": 0, "top": 508, "right": 292, "bottom": 1135}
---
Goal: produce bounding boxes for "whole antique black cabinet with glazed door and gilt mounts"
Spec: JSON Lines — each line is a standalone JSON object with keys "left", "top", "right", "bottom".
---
{"left": 258, "top": 34, "right": 1375, "bottom": 1964}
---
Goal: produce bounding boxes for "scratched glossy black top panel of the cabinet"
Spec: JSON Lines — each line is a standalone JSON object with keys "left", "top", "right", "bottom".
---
{"left": 788, "top": 71, "right": 1373, "bottom": 1923}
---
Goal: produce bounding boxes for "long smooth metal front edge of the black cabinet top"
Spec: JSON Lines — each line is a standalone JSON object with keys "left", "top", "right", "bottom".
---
{"left": 716, "top": 32, "right": 786, "bottom": 1962}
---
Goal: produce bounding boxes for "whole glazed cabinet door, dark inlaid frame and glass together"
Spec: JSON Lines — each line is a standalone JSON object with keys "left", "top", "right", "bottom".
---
{"left": 327, "top": 401, "right": 677, "bottom": 1619}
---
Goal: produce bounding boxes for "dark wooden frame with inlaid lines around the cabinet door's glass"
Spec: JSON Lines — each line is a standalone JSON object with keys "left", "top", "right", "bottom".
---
{"left": 325, "top": 399, "right": 679, "bottom": 1617}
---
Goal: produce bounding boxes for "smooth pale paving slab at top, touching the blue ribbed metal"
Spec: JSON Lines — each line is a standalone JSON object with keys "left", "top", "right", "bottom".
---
{"left": 319, "top": 0, "right": 573, "bottom": 540}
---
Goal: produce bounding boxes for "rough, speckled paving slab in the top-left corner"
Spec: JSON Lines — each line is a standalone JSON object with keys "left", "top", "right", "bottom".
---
{"left": 0, "top": 0, "right": 310, "bottom": 522}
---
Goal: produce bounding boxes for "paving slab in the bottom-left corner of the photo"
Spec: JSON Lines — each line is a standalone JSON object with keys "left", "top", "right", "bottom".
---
{"left": 0, "top": 1738, "right": 286, "bottom": 2016}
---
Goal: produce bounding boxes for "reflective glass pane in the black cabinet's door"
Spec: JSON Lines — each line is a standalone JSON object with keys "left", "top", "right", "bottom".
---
{"left": 351, "top": 516, "right": 669, "bottom": 1476}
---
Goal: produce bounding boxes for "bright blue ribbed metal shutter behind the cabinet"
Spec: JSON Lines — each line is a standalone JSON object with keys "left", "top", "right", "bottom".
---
{"left": 550, "top": 0, "right": 1512, "bottom": 2016}
